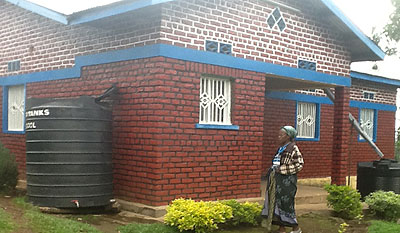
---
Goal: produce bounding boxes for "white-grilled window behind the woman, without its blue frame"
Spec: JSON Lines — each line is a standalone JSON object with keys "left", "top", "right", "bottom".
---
{"left": 297, "top": 102, "right": 317, "bottom": 138}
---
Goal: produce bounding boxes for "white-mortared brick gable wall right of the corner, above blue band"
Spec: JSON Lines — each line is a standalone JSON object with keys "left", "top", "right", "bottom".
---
{"left": 161, "top": 0, "right": 350, "bottom": 76}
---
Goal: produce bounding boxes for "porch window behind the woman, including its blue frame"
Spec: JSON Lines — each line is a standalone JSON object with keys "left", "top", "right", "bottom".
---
{"left": 296, "top": 101, "right": 321, "bottom": 141}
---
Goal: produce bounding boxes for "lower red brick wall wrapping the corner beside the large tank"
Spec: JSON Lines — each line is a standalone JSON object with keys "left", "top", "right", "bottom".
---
{"left": 2, "top": 57, "right": 265, "bottom": 205}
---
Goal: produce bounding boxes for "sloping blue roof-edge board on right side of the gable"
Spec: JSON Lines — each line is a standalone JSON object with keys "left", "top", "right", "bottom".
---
{"left": 321, "top": 0, "right": 385, "bottom": 60}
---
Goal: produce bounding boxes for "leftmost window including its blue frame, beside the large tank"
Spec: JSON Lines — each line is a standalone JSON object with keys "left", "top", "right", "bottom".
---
{"left": 2, "top": 85, "right": 26, "bottom": 134}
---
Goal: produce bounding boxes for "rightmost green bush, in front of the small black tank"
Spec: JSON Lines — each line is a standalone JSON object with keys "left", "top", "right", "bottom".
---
{"left": 365, "top": 191, "right": 400, "bottom": 221}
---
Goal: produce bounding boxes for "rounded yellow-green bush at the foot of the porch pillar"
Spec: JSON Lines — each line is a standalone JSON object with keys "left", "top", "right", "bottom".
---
{"left": 325, "top": 185, "right": 362, "bottom": 219}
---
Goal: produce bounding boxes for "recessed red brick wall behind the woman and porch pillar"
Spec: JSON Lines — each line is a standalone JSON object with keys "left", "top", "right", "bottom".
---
{"left": 262, "top": 98, "right": 395, "bottom": 178}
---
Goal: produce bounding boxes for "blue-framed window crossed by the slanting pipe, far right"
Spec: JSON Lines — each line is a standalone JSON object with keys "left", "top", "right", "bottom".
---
{"left": 358, "top": 108, "right": 378, "bottom": 142}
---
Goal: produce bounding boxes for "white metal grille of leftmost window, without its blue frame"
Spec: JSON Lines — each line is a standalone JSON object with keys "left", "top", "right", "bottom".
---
{"left": 7, "top": 85, "right": 25, "bottom": 131}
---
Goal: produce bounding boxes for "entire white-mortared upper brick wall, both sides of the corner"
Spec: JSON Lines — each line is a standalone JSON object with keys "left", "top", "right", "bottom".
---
{"left": 0, "top": 0, "right": 350, "bottom": 76}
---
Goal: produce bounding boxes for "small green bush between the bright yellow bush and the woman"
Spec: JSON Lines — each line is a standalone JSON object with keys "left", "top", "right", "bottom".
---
{"left": 222, "top": 200, "right": 262, "bottom": 226}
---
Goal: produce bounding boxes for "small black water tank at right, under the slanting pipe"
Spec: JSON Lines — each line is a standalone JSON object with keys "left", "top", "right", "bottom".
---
{"left": 357, "top": 159, "right": 400, "bottom": 198}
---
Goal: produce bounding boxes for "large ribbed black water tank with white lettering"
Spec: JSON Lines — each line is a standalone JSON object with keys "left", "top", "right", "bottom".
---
{"left": 26, "top": 97, "right": 113, "bottom": 208}
